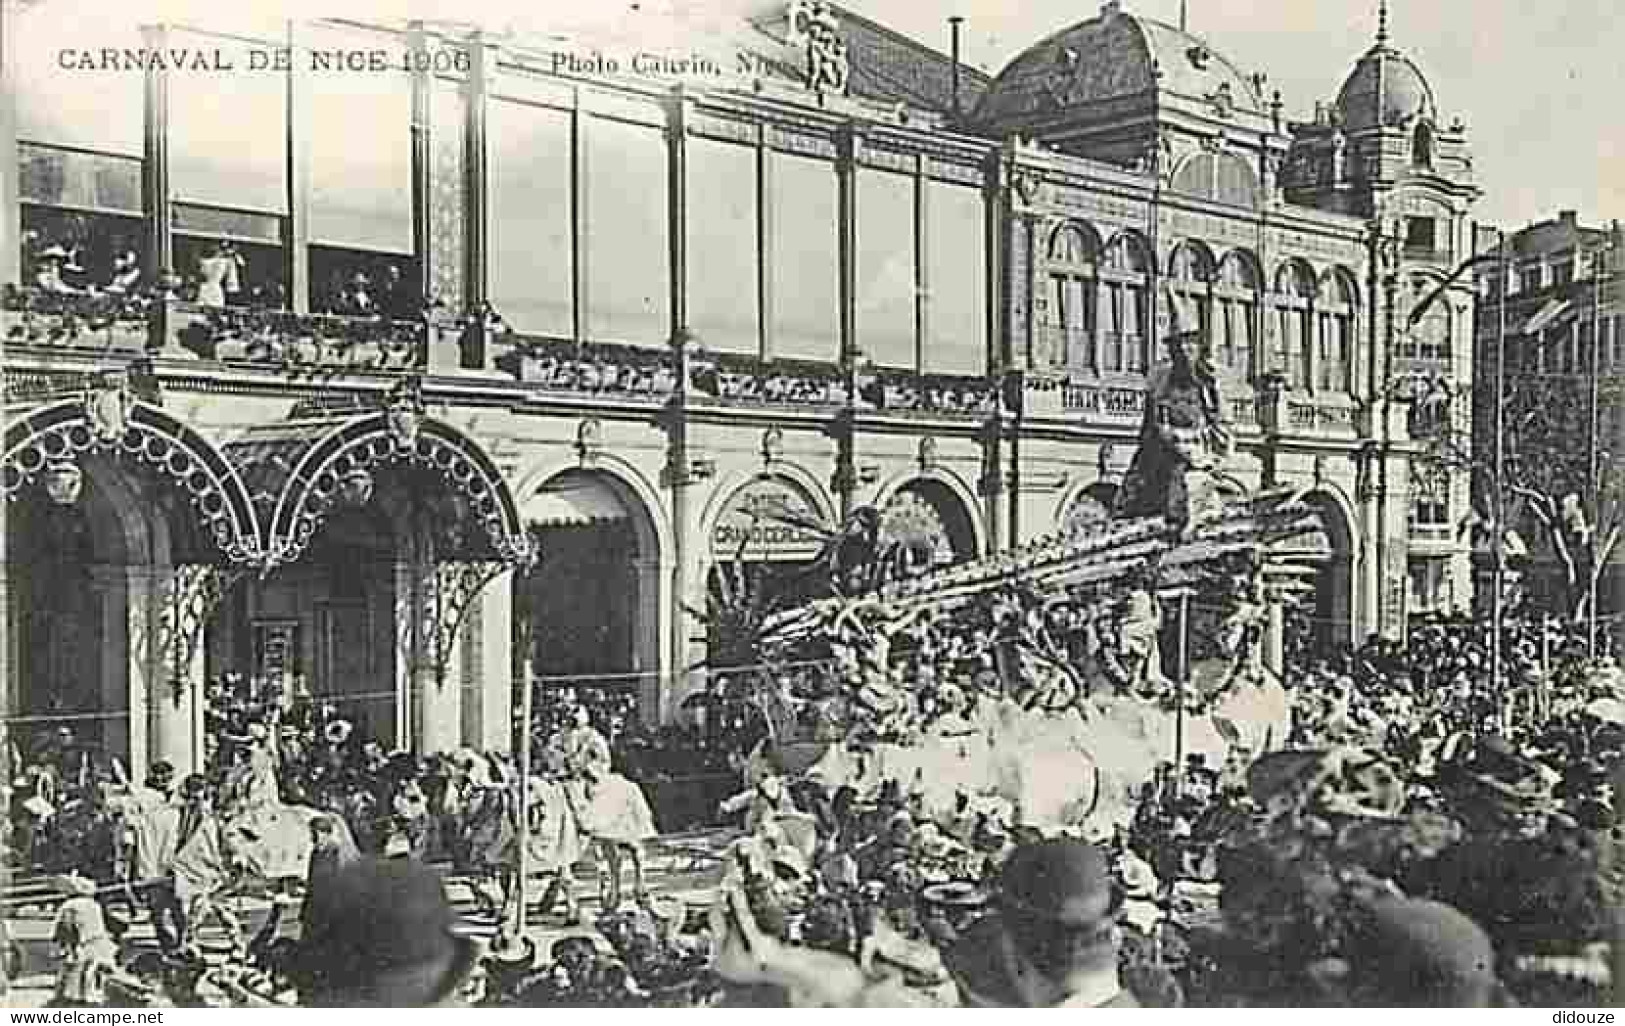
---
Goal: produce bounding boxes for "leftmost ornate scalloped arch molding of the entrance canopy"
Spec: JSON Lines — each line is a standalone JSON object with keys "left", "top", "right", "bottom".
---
{"left": 0, "top": 396, "right": 268, "bottom": 567}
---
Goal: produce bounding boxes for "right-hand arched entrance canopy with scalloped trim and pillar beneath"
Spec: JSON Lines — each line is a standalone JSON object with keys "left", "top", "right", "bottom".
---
{"left": 223, "top": 379, "right": 533, "bottom": 751}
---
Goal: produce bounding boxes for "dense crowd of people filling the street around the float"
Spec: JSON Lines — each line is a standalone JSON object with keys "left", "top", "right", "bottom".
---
{"left": 11, "top": 618, "right": 1625, "bottom": 1006}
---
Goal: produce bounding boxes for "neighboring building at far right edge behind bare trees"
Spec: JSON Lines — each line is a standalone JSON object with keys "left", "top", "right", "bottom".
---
{"left": 1472, "top": 210, "right": 1625, "bottom": 630}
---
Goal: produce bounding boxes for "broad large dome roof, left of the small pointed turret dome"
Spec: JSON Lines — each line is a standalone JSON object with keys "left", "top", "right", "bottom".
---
{"left": 977, "top": 3, "right": 1263, "bottom": 122}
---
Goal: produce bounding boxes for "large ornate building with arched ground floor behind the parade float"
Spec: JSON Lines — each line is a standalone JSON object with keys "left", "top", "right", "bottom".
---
{"left": 0, "top": 2, "right": 1477, "bottom": 766}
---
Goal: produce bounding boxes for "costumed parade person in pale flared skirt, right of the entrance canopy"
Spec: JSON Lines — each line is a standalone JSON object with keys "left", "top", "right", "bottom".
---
{"left": 566, "top": 707, "right": 655, "bottom": 911}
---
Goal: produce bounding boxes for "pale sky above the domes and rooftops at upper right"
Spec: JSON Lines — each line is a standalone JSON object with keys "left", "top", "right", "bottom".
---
{"left": 842, "top": 0, "right": 1625, "bottom": 228}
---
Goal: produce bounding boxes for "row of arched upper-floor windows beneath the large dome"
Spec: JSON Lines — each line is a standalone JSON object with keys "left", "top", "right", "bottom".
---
{"left": 1040, "top": 221, "right": 1360, "bottom": 392}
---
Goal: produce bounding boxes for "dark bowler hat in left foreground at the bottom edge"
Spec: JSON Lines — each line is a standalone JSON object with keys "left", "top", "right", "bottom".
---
{"left": 301, "top": 859, "right": 479, "bottom": 1008}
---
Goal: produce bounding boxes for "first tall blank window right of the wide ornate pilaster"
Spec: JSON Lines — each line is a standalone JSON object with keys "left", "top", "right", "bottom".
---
{"left": 486, "top": 98, "right": 575, "bottom": 335}
